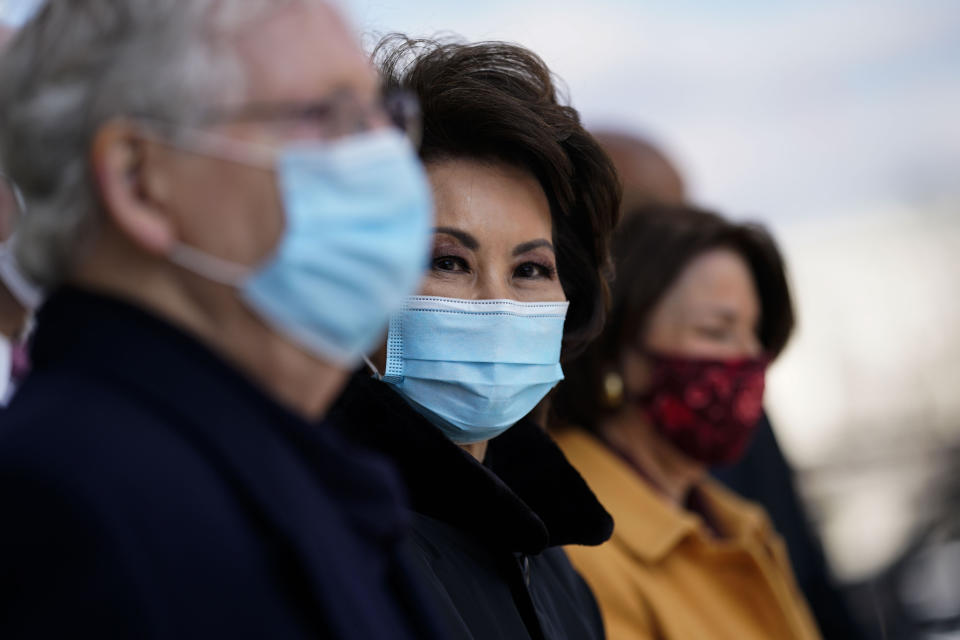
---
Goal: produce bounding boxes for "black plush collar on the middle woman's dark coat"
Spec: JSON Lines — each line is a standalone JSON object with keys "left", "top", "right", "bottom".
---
{"left": 330, "top": 373, "right": 613, "bottom": 553}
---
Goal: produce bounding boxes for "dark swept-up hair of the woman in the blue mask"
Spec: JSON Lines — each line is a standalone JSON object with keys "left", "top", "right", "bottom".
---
{"left": 373, "top": 34, "right": 620, "bottom": 359}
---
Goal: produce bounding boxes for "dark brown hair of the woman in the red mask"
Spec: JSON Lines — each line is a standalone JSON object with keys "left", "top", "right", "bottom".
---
{"left": 551, "top": 206, "right": 794, "bottom": 430}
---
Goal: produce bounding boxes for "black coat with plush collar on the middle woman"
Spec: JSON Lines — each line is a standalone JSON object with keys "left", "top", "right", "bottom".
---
{"left": 329, "top": 374, "right": 613, "bottom": 640}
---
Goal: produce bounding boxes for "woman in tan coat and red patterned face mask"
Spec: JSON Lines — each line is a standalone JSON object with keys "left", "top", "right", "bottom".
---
{"left": 551, "top": 207, "right": 819, "bottom": 640}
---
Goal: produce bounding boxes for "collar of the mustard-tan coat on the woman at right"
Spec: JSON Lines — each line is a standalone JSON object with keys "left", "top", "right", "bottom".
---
{"left": 557, "top": 428, "right": 773, "bottom": 564}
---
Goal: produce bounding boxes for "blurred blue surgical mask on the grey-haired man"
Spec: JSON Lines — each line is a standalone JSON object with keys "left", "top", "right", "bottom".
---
{"left": 170, "top": 129, "right": 433, "bottom": 367}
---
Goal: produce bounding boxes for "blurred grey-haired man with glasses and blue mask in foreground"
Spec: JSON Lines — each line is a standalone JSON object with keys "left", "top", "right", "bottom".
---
{"left": 0, "top": 0, "right": 435, "bottom": 640}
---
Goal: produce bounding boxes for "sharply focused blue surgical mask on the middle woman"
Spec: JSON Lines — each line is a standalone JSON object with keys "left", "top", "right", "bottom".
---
{"left": 383, "top": 296, "right": 569, "bottom": 444}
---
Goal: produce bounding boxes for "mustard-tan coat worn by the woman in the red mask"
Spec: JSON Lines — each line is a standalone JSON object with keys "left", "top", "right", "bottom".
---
{"left": 557, "top": 429, "right": 820, "bottom": 640}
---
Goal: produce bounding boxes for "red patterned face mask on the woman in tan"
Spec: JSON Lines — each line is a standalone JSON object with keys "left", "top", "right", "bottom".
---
{"left": 634, "top": 353, "right": 768, "bottom": 465}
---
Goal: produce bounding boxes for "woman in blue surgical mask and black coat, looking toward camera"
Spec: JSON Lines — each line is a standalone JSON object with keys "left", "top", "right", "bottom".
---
{"left": 330, "top": 36, "right": 619, "bottom": 640}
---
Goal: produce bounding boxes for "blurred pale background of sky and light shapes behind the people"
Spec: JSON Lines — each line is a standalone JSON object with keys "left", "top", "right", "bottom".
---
{"left": 342, "top": 0, "right": 960, "bottom": 638}
